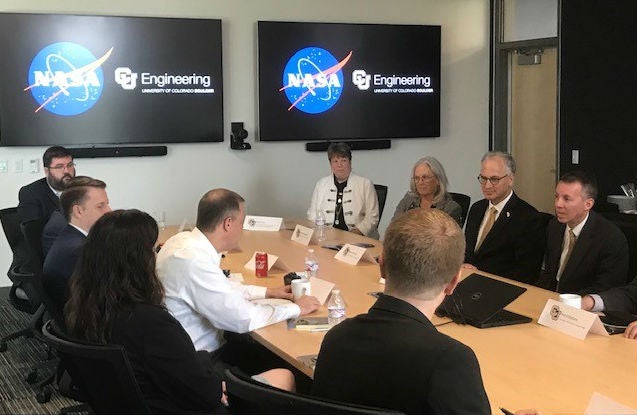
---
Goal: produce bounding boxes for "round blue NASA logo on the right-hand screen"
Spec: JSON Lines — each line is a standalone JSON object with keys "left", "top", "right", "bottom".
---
{"left": 279, "top": 46, "right": 352, "bottom": 114}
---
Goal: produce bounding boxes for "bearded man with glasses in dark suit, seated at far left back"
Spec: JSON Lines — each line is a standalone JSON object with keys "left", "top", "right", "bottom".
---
{"left": 18, "top": 146, "right": 75, "bottom": 222}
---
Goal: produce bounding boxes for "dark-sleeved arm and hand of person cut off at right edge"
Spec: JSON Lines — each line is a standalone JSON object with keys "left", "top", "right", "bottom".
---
{"left": 582, "top": 277, "right": 637, "bottom": 339}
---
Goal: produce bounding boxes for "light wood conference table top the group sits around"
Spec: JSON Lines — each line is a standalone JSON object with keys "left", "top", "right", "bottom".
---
{"left": 160, "top": 220, "right": 637, "bottom": 415}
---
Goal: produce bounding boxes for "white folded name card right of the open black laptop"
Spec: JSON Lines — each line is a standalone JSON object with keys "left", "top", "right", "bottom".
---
{"left": 537, "top": 299, "right": 609, "bottom": 340}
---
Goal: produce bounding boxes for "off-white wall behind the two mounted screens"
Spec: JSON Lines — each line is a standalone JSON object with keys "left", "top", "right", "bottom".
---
{"left": 0, "top": 0, "right": 489, "bottom": 286}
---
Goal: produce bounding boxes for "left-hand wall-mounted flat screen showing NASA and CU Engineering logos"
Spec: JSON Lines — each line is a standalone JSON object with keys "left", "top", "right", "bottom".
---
{"left": 0, "top": 13, "right": 223, "bottom": 146}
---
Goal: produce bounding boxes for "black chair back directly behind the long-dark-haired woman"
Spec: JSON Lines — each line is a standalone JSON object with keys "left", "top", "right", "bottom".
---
{"left": 42, "top": 321, "right": 150, "bottom": 415}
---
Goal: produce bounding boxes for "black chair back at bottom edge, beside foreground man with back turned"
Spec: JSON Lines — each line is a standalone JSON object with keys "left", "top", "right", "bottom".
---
{"left": 225, "top": 369, "right": 404, "bottom": 415}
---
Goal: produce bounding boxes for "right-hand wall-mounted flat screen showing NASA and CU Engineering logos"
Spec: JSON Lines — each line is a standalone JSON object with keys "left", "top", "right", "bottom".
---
{"left": 258, "top": 21, "right": 440, "bottom": 141}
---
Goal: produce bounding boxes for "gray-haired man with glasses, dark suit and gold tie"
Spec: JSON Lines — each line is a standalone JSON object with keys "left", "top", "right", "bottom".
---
{"left": 465, "top": 151, "right": 545, "bottom": 283}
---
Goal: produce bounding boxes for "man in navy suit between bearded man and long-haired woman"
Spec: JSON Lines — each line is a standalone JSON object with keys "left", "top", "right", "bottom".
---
{"left": 42, "top": 176, "right": 111, "bottom": 316}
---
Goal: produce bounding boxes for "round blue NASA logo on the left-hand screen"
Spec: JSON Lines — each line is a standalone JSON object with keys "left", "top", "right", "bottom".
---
{"left": 24, "top": 42, "right": 113, "bottom": 116}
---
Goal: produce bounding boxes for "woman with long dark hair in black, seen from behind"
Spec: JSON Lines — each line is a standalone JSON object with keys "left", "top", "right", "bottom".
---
{"left": 65, "top": 210, "right": 222, "bottom": 414}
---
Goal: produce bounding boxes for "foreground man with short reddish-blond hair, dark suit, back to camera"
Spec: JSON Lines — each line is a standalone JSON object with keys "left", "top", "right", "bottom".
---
{"left": 312, "top": 209, "right": 491, "bottom": 414}
